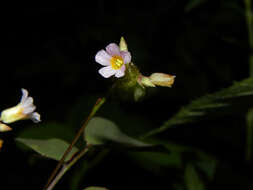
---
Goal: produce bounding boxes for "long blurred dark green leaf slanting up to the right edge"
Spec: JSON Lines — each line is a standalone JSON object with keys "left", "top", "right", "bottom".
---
{"left": 142, "top": 78, "right": 253, "bottom": 138}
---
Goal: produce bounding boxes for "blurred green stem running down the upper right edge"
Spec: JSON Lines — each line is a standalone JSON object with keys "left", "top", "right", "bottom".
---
{"left": 244, "top": 0, "right": 253, "bottom": 76}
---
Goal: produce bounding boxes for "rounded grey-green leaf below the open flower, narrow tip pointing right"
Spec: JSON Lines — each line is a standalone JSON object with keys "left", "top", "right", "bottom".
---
{"left": 84, "top": 117, "right": 150, "bottom": 147}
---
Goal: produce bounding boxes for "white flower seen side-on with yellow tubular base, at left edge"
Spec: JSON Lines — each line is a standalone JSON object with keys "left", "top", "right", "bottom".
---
{"left": 0, "top": 88, "right": 40, "bottom": 123}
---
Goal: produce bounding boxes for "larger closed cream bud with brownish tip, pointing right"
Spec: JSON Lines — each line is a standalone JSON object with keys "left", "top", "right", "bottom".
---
{"left": 149, "top": 73, "right": 176, "bottom": 87}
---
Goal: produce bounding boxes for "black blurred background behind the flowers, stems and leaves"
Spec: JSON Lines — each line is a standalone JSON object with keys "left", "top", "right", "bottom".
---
{"left": 0, "top": 0, "right": 253, "bottom": 190}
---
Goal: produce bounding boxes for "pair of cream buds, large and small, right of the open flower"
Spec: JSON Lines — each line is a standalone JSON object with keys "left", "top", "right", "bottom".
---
{"left": 138, "top": 73, "right": 176, "bottom": 87}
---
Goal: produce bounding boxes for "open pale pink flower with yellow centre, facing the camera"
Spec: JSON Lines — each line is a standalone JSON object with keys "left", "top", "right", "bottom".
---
{"left": 95, "top": 43, "right": 131, "bottom": 78}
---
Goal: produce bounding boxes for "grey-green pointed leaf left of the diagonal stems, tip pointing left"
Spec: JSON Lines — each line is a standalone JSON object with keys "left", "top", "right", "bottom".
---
{"left": 16, "top": 138, "right": 78, "bottom": 161}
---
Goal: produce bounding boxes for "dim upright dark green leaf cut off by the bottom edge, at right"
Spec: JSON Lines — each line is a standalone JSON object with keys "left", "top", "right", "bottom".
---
{"left": 184, "top": 164, "right": 205, "bottom": 190}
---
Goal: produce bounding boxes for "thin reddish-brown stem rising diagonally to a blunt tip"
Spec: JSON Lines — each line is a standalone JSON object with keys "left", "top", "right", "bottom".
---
{"left": 43, "top": 98, "right": 106, "bottom": 190}
